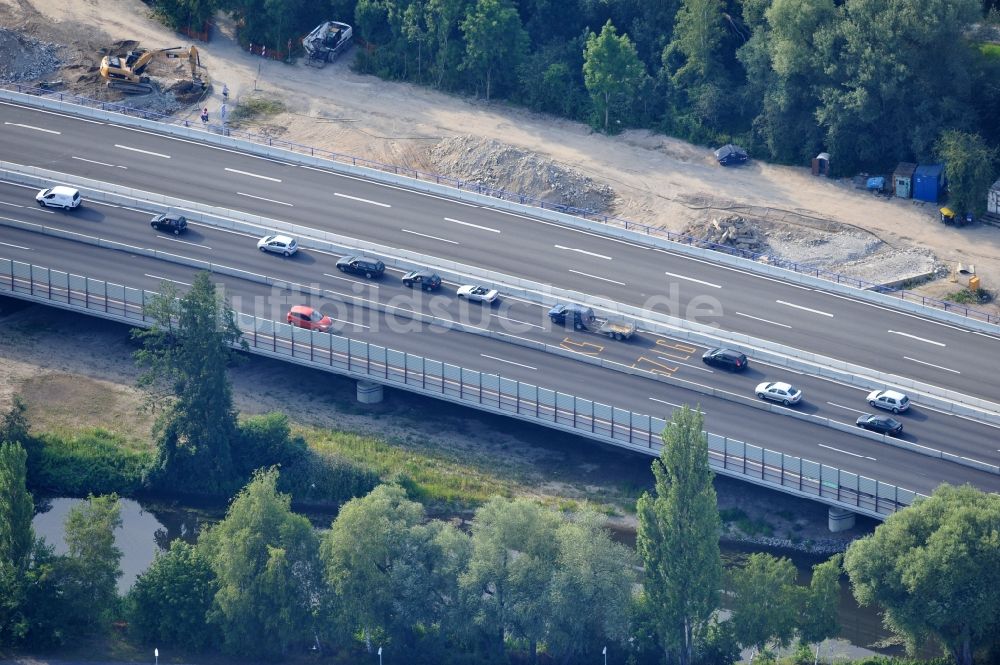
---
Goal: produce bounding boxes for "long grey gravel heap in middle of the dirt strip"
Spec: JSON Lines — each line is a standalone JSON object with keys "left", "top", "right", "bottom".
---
{"left": 431, "top": 136, "right": 615, "bottom": 212}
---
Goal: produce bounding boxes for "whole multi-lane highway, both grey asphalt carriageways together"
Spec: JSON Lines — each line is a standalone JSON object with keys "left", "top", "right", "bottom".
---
{"left": 0, "top": 87, "right": 1000, "bottom": 524}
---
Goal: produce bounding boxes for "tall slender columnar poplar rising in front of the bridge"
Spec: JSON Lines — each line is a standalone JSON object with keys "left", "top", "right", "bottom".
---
{"left": 636, "top": 407, "right": 722, "bottom": 665}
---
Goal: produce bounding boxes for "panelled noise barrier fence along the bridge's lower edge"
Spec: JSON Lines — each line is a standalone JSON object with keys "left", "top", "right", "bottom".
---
{"left": 0, "top": 258, "right": 920, "bottom": 519}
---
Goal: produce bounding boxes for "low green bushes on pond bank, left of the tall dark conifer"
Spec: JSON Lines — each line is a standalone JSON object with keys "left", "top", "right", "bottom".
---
{"left": 26, "top": 428, "right": 153, "bottom": 496}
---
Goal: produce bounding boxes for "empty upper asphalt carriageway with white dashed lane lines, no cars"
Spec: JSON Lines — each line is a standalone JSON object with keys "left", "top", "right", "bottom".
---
{"left": 0, "top": 97, "right": 1000, "bottom": 404}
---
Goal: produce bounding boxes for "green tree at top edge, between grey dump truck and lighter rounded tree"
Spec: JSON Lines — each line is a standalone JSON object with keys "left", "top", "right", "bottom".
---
{"left": 460, "top": 0, "right": 528, "bottom": 102}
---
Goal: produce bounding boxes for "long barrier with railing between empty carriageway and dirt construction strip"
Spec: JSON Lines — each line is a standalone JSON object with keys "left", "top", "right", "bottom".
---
{"left": 0, "top": 83, "right": 1000, "bottom": 324}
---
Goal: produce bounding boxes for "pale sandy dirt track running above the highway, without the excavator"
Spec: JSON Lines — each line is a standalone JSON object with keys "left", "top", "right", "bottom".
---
{"left": 0, "top": 0, "right": 1000, "bottom": 300}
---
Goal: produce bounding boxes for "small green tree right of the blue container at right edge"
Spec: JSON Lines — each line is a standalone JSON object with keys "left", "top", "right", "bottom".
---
{"left": 935, "top": 130, "right": 997, "bottom": 215}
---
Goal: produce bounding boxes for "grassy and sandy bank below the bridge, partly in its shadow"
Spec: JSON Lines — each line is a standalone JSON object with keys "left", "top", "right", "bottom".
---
{"left": 0, "top": 299, "right": 876, "bottom": 554}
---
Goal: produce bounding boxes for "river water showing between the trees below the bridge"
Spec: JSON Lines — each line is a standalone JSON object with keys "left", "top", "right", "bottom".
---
{"left": 32, "top": 498, "right": 897, "bottom": 653}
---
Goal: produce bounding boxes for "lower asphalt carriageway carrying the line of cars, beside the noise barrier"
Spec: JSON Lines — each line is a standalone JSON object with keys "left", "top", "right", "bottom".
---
{"left": 0, "top": 185, "right": 1000, "bottom": 493}
